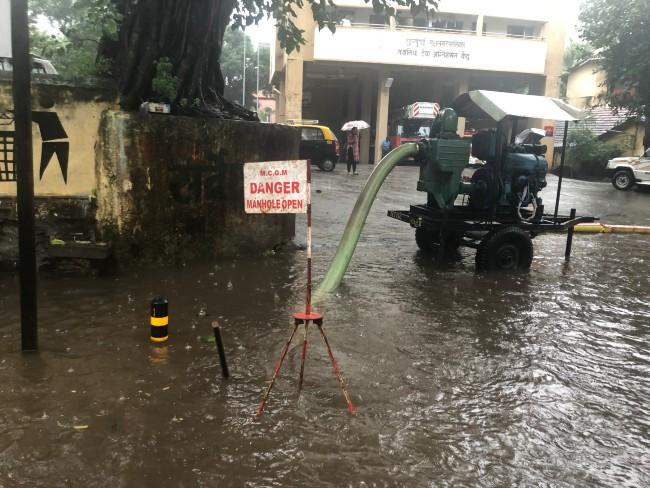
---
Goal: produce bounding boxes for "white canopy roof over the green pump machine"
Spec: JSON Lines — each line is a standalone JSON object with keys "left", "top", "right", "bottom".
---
{"left": 451, "top": 90, "right": 584, "bottom": 122}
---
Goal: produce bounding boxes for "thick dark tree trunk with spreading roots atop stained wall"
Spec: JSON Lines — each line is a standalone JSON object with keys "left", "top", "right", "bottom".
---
{"left": 109, "top": 0, "right": 256, "bottom": 119}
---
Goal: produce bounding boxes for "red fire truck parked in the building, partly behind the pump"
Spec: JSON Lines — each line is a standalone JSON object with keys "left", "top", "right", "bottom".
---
{"left": 388, "top": 102, "right": 440, "bottom": 148}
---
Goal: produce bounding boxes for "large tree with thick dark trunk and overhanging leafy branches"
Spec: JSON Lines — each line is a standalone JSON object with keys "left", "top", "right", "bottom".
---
{"left": 105, "top": 0, "right": 437, "bottom": 116}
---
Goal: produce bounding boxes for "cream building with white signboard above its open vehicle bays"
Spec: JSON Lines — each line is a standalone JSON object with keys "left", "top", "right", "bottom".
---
{"left": 272, "top": 0, "right": 566, "bottom": 162}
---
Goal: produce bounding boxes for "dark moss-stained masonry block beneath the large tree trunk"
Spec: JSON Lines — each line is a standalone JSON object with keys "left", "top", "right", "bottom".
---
{"left": 96, "top": 111, "right": 300, "bottom": 263}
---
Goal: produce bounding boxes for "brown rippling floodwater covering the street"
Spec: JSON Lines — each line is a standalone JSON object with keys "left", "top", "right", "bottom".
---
{"left": 0, "top": 165, "right": 650, "bottom": 488}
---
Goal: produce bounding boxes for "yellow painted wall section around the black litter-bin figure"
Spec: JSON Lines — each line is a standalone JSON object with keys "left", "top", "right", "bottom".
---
{"left": 0, "top": 78, "right": 116, "bottom": 197}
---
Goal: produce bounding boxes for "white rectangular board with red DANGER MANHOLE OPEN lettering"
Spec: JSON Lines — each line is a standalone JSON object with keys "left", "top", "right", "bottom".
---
{"left": 244, "top": 160, "right": 307, "bottom": 213}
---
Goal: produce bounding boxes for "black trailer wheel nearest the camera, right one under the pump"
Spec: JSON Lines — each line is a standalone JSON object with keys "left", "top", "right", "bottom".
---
{"left": 476, "top": 227, "right": 533, "bottom": 271}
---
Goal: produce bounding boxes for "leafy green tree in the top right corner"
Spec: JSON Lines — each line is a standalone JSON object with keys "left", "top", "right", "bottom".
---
{"left": 580, "top": 0, "right": 650, "bottom": 120}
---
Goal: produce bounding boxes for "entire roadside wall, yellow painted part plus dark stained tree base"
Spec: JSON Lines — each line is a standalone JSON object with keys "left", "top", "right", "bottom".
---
{"left": 0, "top": 73, "right": 300, "bottom": 263}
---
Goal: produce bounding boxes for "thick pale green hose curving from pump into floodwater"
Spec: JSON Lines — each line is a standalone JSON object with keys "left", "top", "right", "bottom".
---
{"left": 316, "top": 143, "right": 418, "bottom": 297}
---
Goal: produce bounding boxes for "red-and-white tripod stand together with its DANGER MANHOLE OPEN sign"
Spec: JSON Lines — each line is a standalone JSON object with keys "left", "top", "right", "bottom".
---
{"left": 249, "top": 160, "right": 354, "bottom": 417}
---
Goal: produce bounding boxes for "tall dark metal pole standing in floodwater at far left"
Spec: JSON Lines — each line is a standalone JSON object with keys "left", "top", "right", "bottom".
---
{"left": 11, "top": 0, "right": 38, "bottom": 351}
